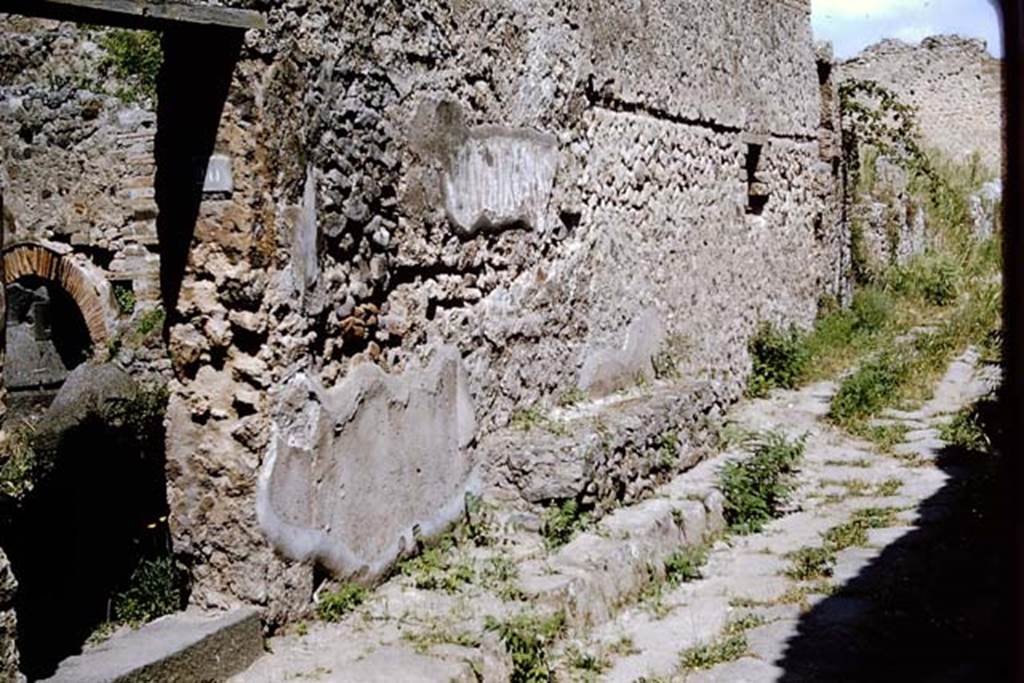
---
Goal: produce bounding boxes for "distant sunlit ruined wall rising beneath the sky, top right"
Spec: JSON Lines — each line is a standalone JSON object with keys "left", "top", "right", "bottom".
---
{"left": 840, "top": 36, "right": 1002, "bottom": 172}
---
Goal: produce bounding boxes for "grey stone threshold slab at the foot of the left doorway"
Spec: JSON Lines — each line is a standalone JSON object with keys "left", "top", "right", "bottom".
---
{"left": 46, "top": 608, "right": 263, "bottom": 683}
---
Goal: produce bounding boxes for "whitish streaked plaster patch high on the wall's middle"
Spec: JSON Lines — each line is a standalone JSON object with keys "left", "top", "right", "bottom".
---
{"left": 443, "top": 126, "right": 558, "bottom": 234}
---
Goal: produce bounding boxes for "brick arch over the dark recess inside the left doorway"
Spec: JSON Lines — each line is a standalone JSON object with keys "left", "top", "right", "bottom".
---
{"left": 3, "top": 243, "right": 114, "bottom": 346}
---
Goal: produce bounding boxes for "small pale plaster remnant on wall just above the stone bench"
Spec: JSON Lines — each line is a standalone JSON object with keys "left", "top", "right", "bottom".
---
{"left": 579, "top": 311, "right": 665, "bottom": 396}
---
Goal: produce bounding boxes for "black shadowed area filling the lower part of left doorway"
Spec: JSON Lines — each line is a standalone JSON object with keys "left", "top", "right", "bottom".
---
{"left": 0, "top": 387, "right": 176, "bottom": 680}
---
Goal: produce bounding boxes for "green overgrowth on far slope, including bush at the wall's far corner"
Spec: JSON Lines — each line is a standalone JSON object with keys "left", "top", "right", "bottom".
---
{"left": 749, "top": 80, "right": 1000, "bottom": 417}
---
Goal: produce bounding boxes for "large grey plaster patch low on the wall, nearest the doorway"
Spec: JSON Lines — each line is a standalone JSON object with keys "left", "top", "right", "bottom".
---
{"left": 257, "top": 347, "right": 477, "bottom": 581}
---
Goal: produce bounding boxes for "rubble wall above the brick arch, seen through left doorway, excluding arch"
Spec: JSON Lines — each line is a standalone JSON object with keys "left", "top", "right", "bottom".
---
{"left": 0, "top": 17, "right": 160, "bottom": 302}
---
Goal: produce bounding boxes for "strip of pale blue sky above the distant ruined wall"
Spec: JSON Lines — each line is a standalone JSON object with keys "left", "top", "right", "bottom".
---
{"left": 811, "top": 0, "right": 1002, "bottom": 57}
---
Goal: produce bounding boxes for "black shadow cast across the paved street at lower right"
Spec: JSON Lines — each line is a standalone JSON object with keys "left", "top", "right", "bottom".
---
{"left": 776, "top": 401, "right": 1011, "bottom": 683}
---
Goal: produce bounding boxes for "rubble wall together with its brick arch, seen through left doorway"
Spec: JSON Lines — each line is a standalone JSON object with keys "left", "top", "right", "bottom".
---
{"left": 0, "top": 16, "right": 170, "bottom": 389}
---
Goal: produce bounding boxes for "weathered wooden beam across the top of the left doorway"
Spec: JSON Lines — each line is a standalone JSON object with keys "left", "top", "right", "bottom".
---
{"left": 0, "top": 0, "right": 266, "bottom": 30}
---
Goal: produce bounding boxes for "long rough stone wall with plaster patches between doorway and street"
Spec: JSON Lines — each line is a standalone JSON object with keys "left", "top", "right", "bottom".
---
{"left": 153, "top": 1, "right": 839, "bottom": 613}
